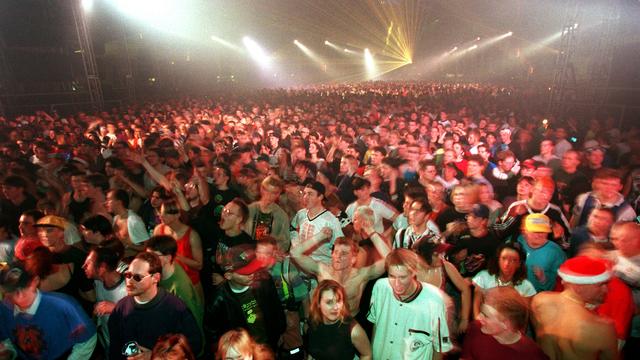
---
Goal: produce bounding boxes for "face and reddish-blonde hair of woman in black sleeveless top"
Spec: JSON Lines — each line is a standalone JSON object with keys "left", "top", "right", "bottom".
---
{"left": 309, "top": 280, "right": 350, "bottom": 326}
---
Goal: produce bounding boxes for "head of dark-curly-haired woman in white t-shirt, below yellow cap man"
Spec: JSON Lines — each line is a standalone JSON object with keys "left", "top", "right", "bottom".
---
{"left": 487, "top": 243, "right": 527, "bottom": 285}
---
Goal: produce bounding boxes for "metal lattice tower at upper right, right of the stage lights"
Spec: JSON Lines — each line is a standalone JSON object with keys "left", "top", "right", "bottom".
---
{"left": 548, "top": 0, "right": 580, "bottom": 118}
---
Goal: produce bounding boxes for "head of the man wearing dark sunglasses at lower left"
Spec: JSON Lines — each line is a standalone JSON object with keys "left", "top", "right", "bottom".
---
{"left": 124, "top": 252, "right": 162, "bottom": 300}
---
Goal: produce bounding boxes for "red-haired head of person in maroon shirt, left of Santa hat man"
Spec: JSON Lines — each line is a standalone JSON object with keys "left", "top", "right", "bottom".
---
{"left": 478, "top": 286, "right": 529, "bottom": 336}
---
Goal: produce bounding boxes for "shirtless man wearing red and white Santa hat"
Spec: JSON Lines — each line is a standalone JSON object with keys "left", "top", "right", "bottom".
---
{"left": 531, "top": 256, "right": 618, "bottom": 360}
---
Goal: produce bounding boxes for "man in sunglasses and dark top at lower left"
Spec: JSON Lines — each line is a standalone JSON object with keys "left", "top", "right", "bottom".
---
{"left": 109, "top": 252, "right": 202, "bottom": 360}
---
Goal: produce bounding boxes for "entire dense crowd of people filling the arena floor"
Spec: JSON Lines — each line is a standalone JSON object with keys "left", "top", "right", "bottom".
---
{"left": 0, "top": 82, "right": 640, "bottom": 360}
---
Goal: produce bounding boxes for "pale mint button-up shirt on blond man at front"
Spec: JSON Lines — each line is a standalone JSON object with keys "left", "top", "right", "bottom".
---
{"left": 367, "top": 278, "right": 453, "bottom": 360}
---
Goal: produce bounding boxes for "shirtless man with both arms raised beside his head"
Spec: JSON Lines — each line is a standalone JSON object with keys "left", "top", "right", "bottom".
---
{"left": 291, "top": 207, "right": 391, "bottom": 316}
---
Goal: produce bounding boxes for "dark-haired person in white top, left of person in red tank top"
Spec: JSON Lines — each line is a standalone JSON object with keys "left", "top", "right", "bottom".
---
{"left": 105, "top": 190, "right": 149, "bottom": 256}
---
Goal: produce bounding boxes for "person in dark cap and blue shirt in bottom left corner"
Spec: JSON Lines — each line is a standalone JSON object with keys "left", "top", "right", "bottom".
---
{"left": 0, "top": 264, "right": 97, "bottom": 360}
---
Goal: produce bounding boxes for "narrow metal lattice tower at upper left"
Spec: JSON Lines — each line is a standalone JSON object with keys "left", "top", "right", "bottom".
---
{"left": 71, "top": 0, "right": 104, "bottom": 110}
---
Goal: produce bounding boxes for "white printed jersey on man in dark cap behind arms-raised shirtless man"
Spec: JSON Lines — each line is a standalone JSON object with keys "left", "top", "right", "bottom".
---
{"left": 291, "top": 209, "right": 344, "bottom": 264}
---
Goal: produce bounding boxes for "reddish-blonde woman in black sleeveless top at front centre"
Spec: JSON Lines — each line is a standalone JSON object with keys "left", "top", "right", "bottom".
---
{"left": 307, "top": 280, "right": 371, "bottom": 360}
